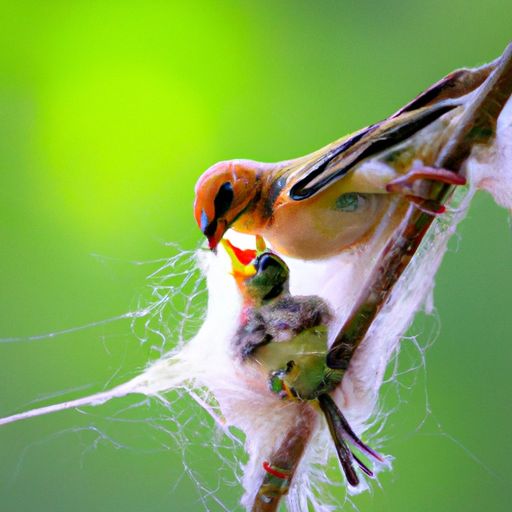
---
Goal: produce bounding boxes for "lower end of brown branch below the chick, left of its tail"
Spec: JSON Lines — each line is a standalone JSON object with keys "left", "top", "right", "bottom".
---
{"left": 251, "top": 402, "right": 317, "bottom": 512}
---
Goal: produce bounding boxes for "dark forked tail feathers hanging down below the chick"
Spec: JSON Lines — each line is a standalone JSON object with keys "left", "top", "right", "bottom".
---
{"left": 318, "top": 394, "right": 384, "bottom": 487}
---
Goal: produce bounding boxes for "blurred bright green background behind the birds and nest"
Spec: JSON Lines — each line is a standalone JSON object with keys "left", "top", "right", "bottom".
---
{"left": 0, "top": 0, "right": 512, "bottom": 512}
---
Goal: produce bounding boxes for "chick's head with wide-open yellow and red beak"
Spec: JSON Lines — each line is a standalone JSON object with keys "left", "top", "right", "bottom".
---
{"left": 222, "top": 236, "right": 290, "bottom": 306}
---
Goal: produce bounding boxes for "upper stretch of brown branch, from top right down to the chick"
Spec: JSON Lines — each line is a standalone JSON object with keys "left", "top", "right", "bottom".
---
{"left": 327, "top": 44, "right": 512, "bottom": 369}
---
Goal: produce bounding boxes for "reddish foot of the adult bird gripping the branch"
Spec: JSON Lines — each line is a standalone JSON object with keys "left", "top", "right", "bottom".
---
{"left": 386, "top": 166, "right": 466, "bottom": 215}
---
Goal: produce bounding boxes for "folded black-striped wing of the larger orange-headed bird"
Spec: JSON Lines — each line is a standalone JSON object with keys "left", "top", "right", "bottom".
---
{"left": 287, "top": 62, "right": 496, "bottom": 201}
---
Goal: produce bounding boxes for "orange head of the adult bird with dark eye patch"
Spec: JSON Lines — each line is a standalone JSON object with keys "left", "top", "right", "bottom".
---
{"left": 194, "top": 160, "right": 262, "bottom": 250}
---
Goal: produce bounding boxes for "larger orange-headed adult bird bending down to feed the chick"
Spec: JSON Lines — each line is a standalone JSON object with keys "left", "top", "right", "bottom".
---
{"left": 190, "top": 63, "right": 495, "bottom": 259}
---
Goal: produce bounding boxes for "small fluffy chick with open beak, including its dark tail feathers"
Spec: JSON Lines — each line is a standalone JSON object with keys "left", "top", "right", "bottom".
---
{"left": 222, "top": 237, "right": 383, "bottom": 486}
